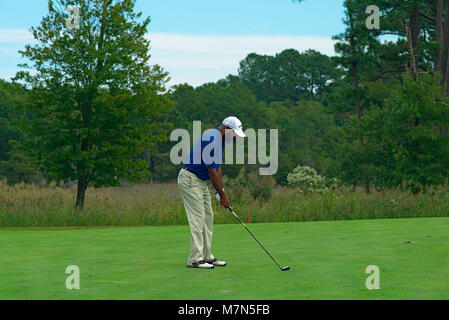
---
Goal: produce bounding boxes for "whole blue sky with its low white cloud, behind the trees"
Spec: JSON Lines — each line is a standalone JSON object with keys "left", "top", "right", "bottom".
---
{"left": 0, "top": 0, "right": 344, "bottom": 85}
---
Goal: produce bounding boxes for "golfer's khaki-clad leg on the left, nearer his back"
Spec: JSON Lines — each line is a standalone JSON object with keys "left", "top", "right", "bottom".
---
{"left": 178, "top": 170, "right": 205, "bottom": 265}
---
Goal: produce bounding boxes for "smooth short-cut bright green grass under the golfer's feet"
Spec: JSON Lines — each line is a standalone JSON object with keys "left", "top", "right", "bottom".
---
{"left": 0, "top": 218, "right": 449, "bottom": 299}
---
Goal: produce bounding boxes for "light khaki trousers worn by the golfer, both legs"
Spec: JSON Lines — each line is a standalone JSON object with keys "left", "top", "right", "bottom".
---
{"left": 178, "top": 169, "right": 214, "bottom": 265}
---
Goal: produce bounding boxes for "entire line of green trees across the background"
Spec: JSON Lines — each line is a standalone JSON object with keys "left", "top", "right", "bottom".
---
{"left": 0, "top": 0, "right": 449, "bottom": 208}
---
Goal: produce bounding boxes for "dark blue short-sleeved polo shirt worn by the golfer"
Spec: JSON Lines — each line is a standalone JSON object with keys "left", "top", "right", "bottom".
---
{"left": 182, "top": 128, "right": 225, "bottom": 180}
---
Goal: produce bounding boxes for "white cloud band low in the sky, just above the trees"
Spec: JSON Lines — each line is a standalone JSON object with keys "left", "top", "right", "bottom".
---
{"left": 0, "top": 29, "right": 335, "bottom": 86}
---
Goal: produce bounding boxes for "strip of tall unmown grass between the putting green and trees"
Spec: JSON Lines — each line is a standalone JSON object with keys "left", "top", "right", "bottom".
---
{"left": 0, "top": 181, "right": 449, "bottom": 227}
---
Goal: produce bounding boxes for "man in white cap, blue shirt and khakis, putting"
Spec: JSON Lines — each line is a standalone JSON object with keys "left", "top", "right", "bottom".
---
{"left": 178, "top": 117, "right": 246, "bottom": 269}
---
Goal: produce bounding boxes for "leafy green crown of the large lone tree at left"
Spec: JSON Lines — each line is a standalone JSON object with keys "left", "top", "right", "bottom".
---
{"left": 12, "top": 0, "right": 169, "bottom": 208}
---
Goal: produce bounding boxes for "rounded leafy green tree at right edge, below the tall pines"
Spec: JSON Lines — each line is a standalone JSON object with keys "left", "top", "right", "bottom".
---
{"left": 340, "top": 75, "right": 449, "bottom": 192}
